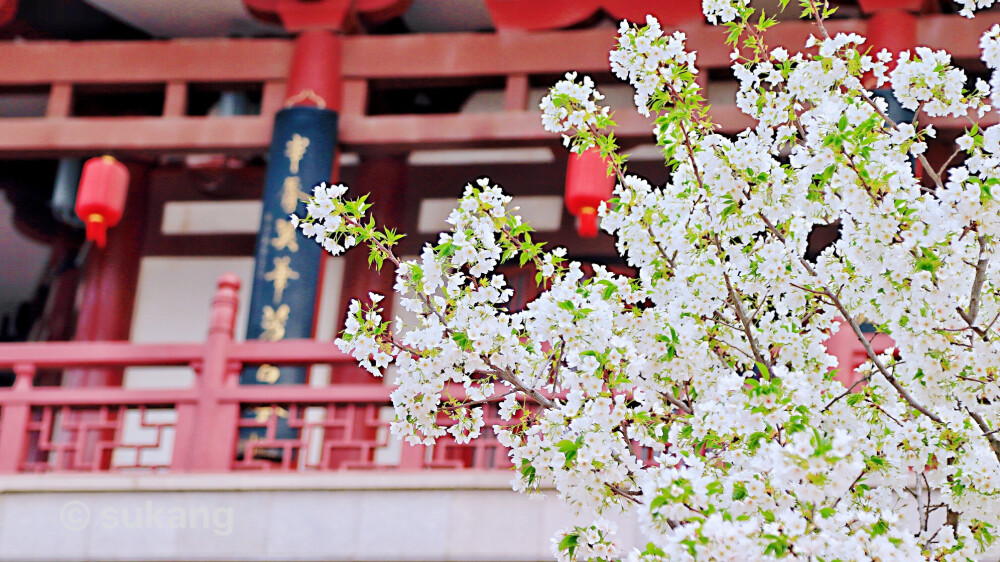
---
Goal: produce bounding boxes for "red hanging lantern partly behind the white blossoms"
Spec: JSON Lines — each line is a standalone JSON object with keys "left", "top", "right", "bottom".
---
{"left": 566, "top": 148, "right": 615, "bottom": 238}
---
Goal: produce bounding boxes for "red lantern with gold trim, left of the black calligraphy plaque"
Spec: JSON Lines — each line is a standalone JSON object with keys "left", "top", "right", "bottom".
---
{"left": 76, "top": 156, "right": 128, "bottom": 248}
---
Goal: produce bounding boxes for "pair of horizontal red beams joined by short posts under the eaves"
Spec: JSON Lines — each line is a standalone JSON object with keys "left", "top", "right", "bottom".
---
{"left": 0, "top": 13, "right": 1000, "bottom": 158}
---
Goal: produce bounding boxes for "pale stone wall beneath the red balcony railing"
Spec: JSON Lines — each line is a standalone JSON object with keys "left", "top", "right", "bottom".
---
{"left": 0, "top": 471, "right": 637, "bottom": 561}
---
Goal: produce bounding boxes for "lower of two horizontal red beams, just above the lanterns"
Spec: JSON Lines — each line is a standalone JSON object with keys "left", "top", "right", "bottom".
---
{"left": 0, "top": 100, "right": 997, "bottom": 158}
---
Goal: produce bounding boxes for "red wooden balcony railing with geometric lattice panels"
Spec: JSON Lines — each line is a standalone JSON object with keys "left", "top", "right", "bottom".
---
{"left": 0, "top": 275, "right": 510, "bottom": 473}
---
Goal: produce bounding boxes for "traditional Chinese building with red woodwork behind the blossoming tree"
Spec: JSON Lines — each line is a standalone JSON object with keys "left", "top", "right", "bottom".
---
{"left": 0, "top": 0, "right": 1000, "bottom": 560}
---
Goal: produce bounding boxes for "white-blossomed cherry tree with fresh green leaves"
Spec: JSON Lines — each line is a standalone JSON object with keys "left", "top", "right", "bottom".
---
{"left": 295, "top": 0, "right": 1000, "bottom": 561}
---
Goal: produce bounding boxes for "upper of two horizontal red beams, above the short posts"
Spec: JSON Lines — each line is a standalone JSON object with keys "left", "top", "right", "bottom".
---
{"left": 0, "top": 12, "right": 1000, "bottom": 85}
